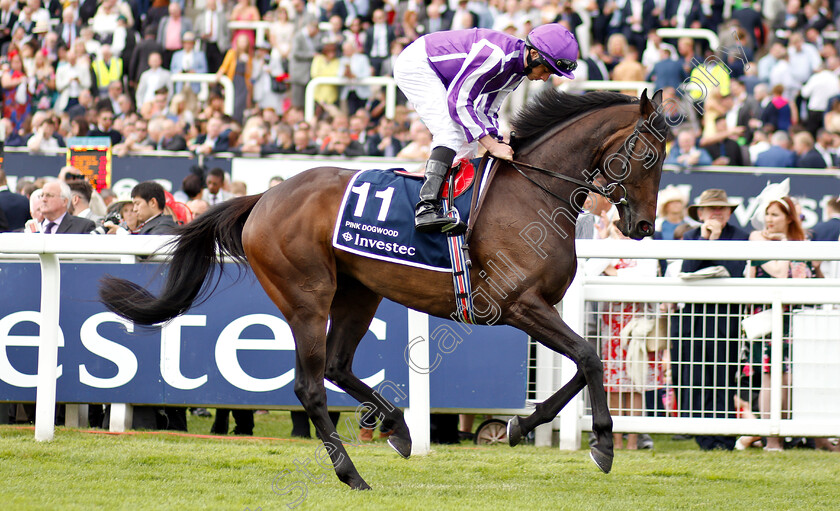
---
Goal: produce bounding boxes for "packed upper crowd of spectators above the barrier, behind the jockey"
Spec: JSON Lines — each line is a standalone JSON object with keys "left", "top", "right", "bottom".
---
{"left": 0, "top": 0, "right": 840, "bottom": 172}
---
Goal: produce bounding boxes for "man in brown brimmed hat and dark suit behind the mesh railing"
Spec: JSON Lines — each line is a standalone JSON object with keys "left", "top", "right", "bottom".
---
{"left": 671, "top": 189, "right": 749, "bottom": 450}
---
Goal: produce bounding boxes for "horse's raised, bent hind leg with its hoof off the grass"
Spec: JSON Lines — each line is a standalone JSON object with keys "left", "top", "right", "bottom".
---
{"left": 326, "top": 275, "right": 411, "bottom": 458}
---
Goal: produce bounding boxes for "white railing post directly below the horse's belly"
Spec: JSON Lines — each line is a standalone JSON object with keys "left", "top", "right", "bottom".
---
{"left": 405, "top": 309, "right": 431, "bottom": 455}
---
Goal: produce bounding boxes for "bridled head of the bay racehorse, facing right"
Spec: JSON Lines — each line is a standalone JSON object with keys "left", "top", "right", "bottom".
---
{"left": 600, "top": 90, "right": 668, "bottom": 240}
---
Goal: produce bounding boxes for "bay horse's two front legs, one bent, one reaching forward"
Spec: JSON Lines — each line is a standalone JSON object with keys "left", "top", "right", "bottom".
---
{"left": 508, "top": 297, "right": 613, "bottom": 473}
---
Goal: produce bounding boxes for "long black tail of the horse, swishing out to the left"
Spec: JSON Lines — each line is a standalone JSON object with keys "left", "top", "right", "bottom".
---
{"left": 99, "top": 194, "right": 262, "bottom": 325}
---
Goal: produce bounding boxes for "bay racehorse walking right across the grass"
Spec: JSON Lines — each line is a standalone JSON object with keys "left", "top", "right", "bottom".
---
{"left": 100, "top": 89, "right": 667, "bottom": 489}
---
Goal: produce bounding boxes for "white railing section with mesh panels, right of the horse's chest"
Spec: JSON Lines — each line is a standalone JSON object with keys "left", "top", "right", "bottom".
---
{"left": 556, "top": 240, "right": 840, "bottom": 449}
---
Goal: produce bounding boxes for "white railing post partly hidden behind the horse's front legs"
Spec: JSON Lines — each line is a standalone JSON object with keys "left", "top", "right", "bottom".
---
{"left": 559, "top": 261, "right": 586, "bottom": 450}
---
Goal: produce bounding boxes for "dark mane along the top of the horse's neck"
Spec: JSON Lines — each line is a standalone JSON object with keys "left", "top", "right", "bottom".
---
{"left": 511, "top": 88, "right": 639, "bottom": 141}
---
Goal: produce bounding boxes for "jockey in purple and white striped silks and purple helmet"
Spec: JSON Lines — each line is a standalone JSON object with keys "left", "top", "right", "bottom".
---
{"left": 394, "top": 23, "right": 578, "bottom": 233}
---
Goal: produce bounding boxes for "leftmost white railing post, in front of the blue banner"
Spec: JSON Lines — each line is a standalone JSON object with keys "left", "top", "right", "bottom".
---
{"left": 35, "top": 254, "right": 61, "bottom": 442}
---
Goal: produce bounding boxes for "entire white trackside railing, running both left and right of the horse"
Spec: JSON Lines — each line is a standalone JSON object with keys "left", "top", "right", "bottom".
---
{"left": 6, "top": 234, "right": 840, "bottom": 453}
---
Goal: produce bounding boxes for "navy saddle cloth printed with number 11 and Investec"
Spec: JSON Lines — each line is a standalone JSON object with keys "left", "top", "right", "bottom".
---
{"left": 333, "top": 169, "right": 476, "bottom": 272}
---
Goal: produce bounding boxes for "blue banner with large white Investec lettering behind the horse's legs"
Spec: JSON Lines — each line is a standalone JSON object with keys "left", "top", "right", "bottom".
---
{"left": 0, "top": 263, "right": 527, "bottom": 408}
